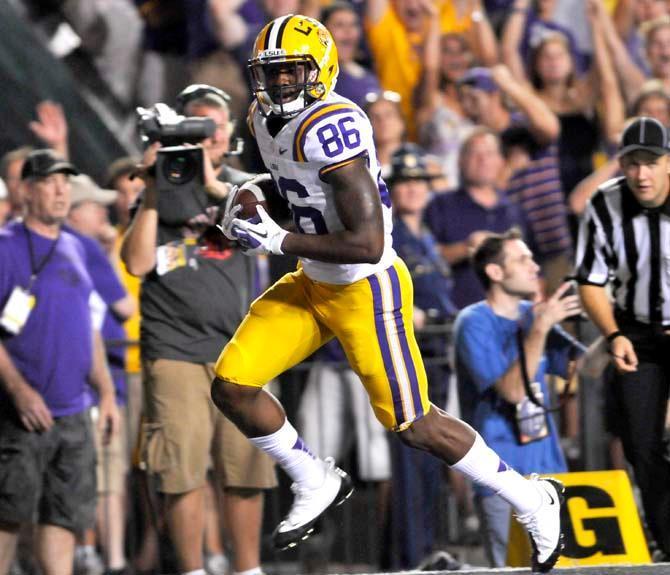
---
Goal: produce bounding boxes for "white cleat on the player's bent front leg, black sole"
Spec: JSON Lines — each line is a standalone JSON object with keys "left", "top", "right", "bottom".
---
{"left": 272, "top": 457, "right": 354, "bottom": 549}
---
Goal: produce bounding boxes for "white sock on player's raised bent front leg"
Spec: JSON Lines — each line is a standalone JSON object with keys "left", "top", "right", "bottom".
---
{"left": 249, "top": 419, "right": 326, "bottom": 489}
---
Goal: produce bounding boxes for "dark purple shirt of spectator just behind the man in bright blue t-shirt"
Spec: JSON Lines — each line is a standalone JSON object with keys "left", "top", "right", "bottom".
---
{"left": 424, "top": 188, "right": 526, "bottom": 309}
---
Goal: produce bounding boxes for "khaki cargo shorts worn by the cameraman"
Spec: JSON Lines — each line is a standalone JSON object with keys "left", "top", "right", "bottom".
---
{"left": 141, "top": 359, "right": 277, "bottom": 493}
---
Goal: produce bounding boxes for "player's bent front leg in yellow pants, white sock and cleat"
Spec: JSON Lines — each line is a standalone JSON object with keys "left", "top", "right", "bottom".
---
{"left": 212, "top": 271, "right": 352, "bottom": 549}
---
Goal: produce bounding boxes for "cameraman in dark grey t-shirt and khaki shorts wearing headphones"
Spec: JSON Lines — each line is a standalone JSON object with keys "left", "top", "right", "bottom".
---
{"left": 121, "top": 85, "right": 276, "bottom": 575}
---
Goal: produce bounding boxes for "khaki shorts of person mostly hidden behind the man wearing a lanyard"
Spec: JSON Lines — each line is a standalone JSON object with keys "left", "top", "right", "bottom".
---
{"left": 91, "top": 407, "right": 129, "bottom": 495}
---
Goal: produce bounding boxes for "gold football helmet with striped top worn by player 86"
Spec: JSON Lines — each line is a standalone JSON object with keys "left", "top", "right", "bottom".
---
{"left": 248, "top": 14, "right": 340, "bottom": 118}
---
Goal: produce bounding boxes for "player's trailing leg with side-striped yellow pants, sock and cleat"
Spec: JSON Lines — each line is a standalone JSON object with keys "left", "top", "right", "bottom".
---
{"left": 328, "top": 260, "right": 562, "bottom": 571}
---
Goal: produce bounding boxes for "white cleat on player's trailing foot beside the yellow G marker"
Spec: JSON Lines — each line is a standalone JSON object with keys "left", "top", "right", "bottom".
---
{"left": 516, "top": 474, "right": 565, "bottom": 573}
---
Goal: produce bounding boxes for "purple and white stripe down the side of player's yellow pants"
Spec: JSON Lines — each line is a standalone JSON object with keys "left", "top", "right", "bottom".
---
{"left": 368, "top": 266, "right": 423, "bottom": 428}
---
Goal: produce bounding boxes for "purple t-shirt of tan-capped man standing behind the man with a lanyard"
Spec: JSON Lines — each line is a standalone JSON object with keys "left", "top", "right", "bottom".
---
{"left": 63, "top": 226, "right": 127, "bottom": 405}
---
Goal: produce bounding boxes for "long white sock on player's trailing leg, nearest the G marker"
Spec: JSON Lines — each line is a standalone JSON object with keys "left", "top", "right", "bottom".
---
{"left": 452, "top": 433, "right": 542, "bottom": 515}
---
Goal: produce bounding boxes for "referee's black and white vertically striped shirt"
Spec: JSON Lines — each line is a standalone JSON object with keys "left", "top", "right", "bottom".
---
{"left": 576, "top": 177, "right": 670, "bottom": 326}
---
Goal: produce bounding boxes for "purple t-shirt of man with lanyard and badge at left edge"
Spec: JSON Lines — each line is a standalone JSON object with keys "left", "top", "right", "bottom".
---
{"left": 0, "top": 221, "right": 93, "bottom": 417}
